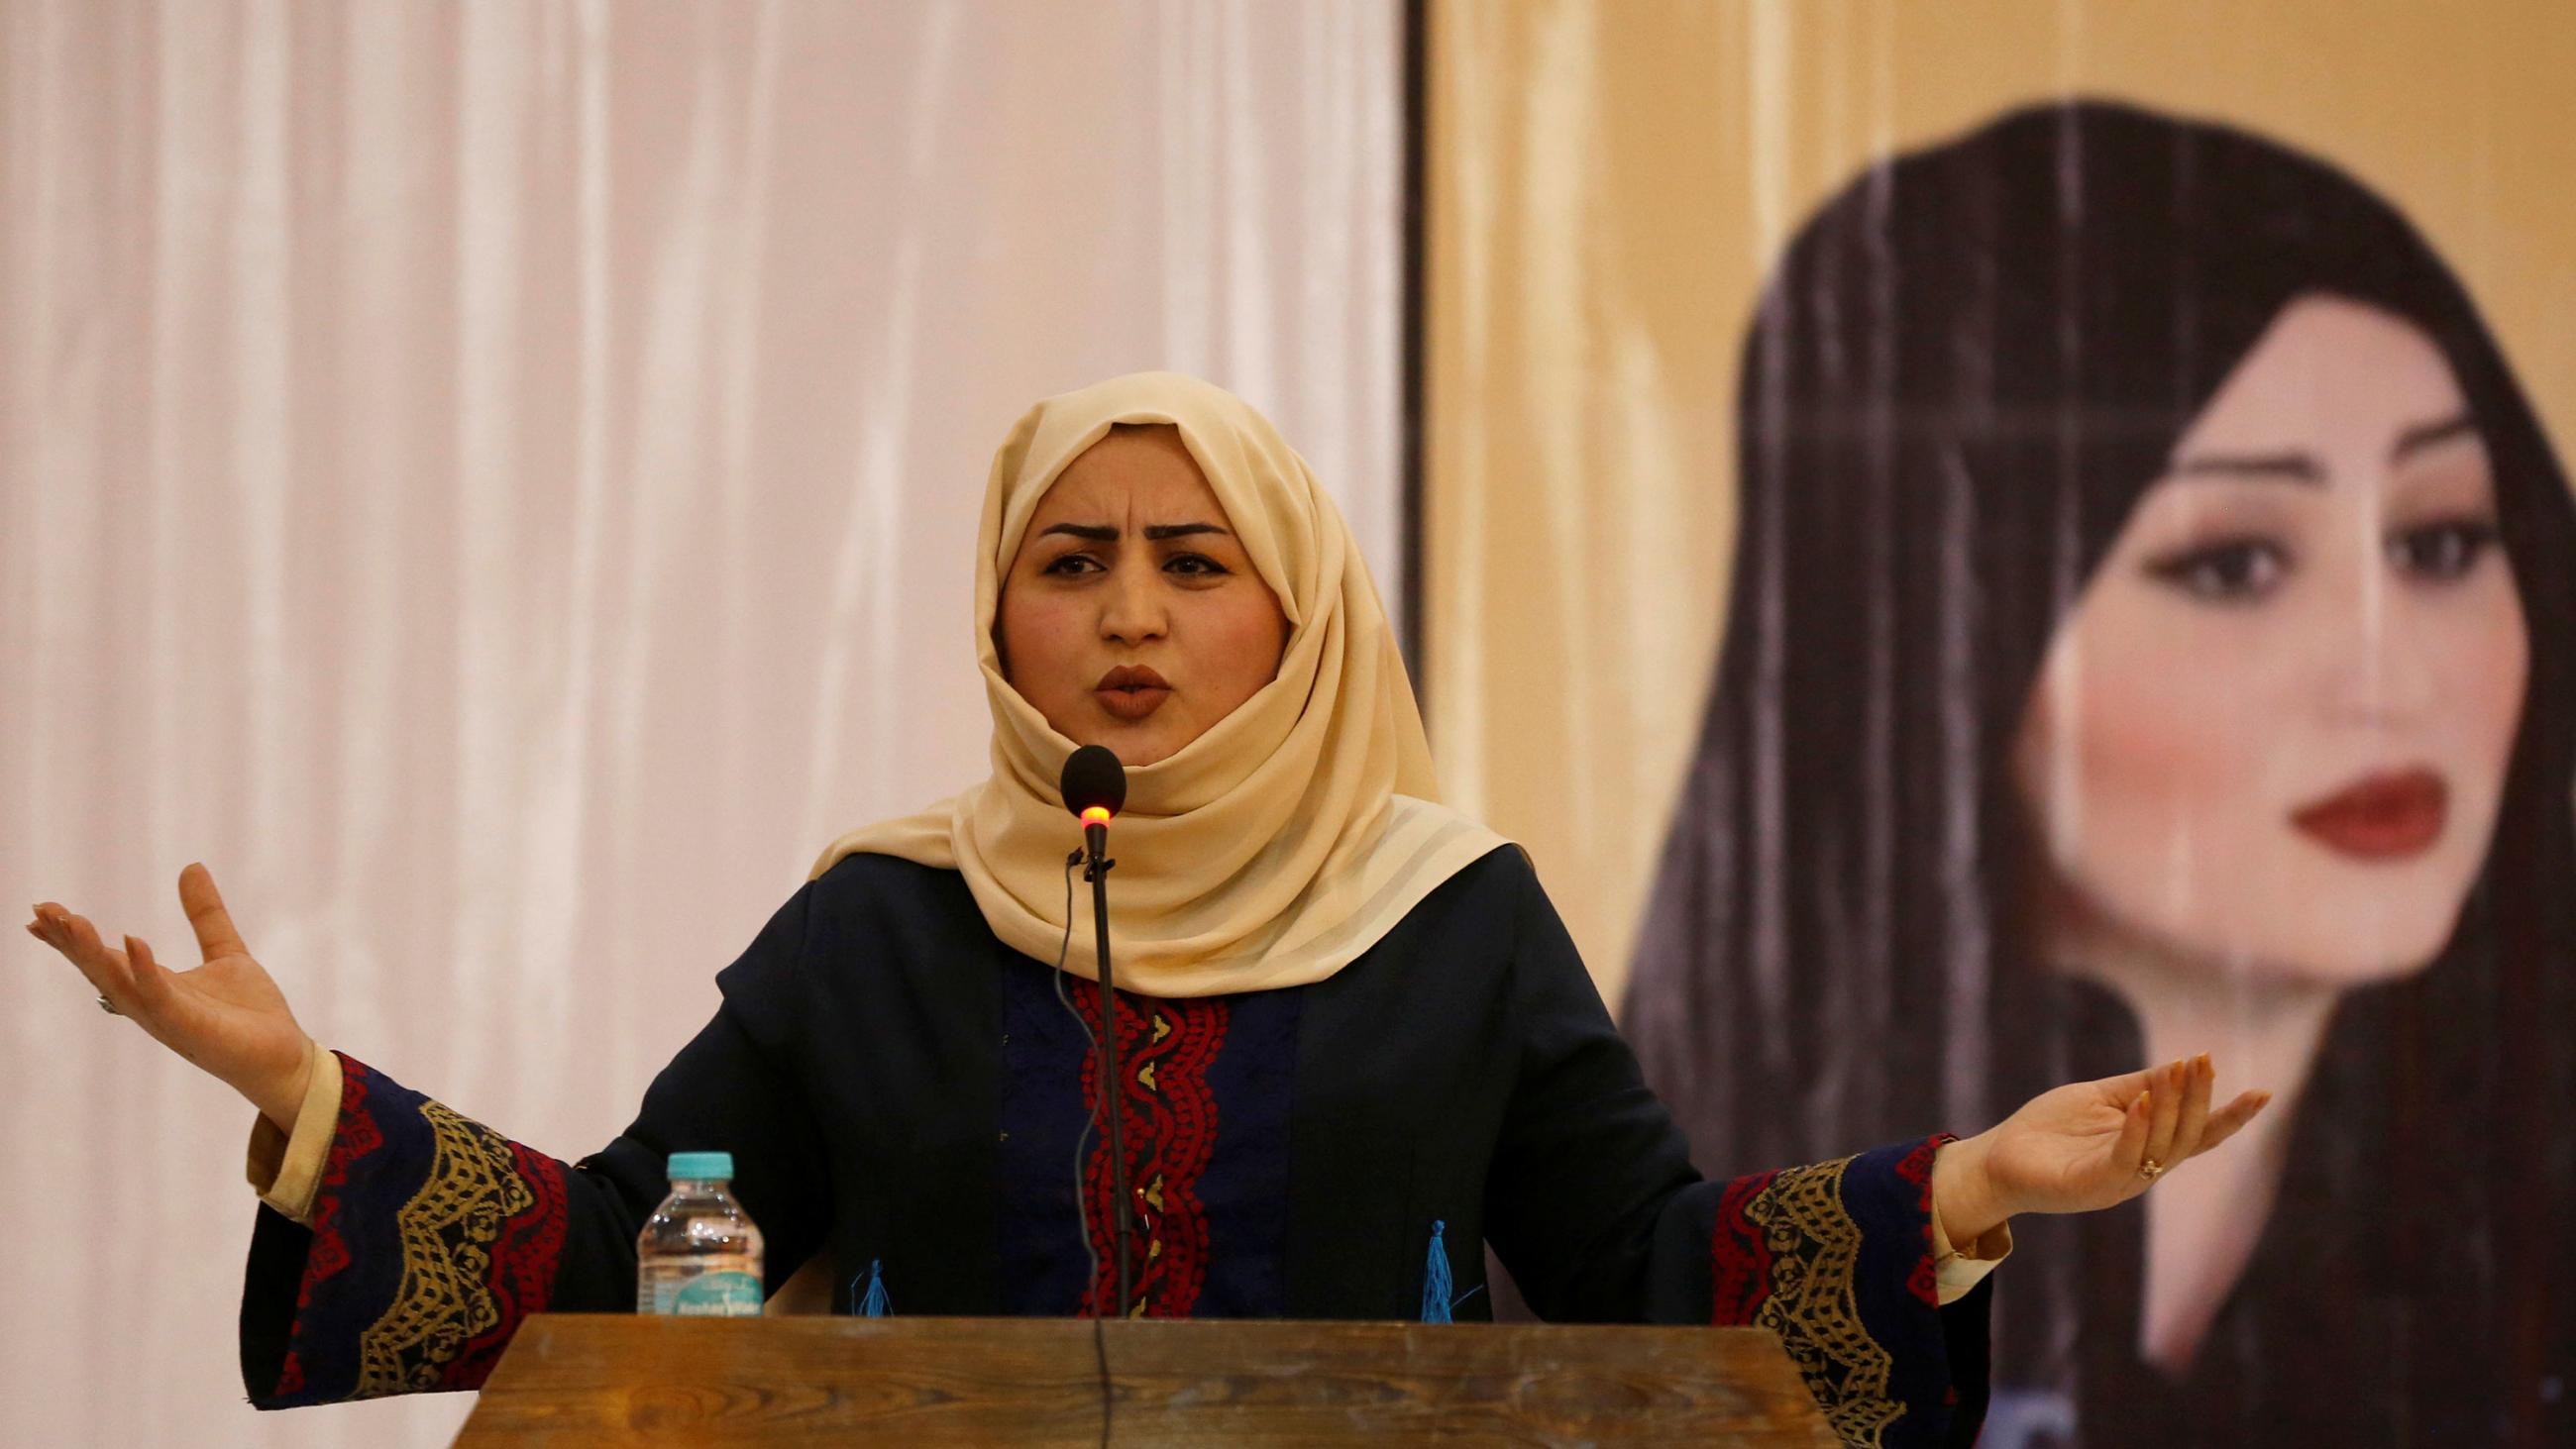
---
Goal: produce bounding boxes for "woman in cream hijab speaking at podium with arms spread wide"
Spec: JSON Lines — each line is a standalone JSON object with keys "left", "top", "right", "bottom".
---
{"left": 29, "top": 373, "right": 2264, "bottom": 1444}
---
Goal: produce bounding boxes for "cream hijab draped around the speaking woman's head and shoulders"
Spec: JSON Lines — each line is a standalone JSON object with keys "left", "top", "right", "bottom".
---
{"left": 814, "top": 373, "right": 1504, "bottom": 996}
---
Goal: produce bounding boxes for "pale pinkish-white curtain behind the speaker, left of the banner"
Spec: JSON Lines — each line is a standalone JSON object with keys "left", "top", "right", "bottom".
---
{"left": 0, "top": 0, "right": 1401, "bottom": 1444}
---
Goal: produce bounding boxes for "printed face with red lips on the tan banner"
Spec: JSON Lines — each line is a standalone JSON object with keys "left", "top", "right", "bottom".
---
{"left": 2014, "top": 296, "right": 2529, "bottom": 985}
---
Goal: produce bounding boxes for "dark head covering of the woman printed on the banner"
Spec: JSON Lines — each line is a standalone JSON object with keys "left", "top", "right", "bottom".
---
{"left": 1626, "top": 100, "right": 2576, "bottom": 1444}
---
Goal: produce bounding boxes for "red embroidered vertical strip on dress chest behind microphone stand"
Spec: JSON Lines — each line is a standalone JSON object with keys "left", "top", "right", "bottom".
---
{"left": 1072, "top": 981, "right": 1229, "bottom": 1317}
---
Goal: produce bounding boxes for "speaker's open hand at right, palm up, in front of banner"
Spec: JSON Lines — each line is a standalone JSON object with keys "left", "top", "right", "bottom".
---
{"left": 1932, "top": 1053, "right": 2272, "bottom": 1248}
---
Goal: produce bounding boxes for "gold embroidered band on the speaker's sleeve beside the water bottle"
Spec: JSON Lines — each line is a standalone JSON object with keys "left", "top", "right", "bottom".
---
{"left": 351, "top": 1101, "right": 536, "bottom": 1397}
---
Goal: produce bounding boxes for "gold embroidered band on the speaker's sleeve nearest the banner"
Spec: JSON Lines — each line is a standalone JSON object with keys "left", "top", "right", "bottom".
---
{"left": 1744, "top": 1158, "right": 1903, "bottom": 1449}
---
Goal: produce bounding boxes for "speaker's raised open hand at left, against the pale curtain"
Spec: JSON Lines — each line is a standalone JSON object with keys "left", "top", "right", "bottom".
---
{"left": 26, "top": 865, "right": 312, "bottom": 1132}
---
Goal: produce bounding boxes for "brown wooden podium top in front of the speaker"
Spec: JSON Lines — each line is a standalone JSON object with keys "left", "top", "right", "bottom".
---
{"left": 456, "top": 1312, "right": 1834, "bottom": 1449}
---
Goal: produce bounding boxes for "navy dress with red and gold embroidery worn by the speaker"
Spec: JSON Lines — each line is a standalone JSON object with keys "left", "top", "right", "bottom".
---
{"left": 242, "top": 850, "right": 1991, "bottom": 1446}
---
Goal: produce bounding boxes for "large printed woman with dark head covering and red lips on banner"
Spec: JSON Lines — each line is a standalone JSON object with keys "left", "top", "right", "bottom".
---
{"left": 1626, "top": 100, "right": 2576, "bottom": 1444}
